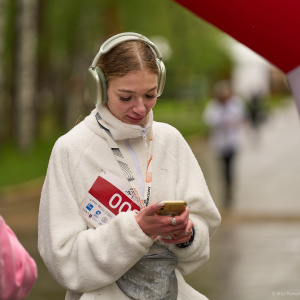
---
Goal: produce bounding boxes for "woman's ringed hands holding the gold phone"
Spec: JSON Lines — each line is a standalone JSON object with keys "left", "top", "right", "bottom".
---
{"left": 135, "top": 202, "right": 193, "bottom": 244}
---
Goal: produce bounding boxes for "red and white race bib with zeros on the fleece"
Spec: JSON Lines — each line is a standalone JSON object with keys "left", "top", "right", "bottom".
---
{"left": 79, "top": 172, "right": 140, "bottom": 227}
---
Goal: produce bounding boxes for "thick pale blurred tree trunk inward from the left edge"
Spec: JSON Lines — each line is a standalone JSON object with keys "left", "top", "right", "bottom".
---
{"left": 14, "top": 0, "right": 38, "bottom": 152}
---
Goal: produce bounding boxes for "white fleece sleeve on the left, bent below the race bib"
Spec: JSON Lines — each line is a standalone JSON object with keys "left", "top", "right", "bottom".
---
{"left": 38, "top": 140, "right": 153, "bottom": 293}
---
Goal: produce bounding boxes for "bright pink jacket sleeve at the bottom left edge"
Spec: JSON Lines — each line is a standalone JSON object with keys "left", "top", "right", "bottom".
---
{"left": 0, "top": 216, "right": 37, "bottom": 300}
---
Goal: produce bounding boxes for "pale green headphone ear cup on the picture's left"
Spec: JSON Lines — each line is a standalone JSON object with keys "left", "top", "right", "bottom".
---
{"left": 87, "top": 67, "right": 107, "bottom": 105}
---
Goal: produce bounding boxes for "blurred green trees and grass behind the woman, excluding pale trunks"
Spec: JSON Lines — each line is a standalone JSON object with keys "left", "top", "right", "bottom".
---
{"left": 0, "top": 0, "right": 231, "bottom": 187}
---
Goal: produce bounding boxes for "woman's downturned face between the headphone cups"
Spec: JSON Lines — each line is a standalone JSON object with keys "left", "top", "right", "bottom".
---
{"left": 107, "top": 71, "right": 157, "bottom": 126}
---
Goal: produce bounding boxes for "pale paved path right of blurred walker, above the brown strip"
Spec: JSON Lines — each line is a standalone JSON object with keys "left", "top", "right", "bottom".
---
{"left": 235, "top": 102, "right": 300, "bottom": 216}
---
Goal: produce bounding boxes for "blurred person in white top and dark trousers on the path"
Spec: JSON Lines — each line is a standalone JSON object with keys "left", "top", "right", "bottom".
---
{"left": 203, "top": 80, "right": 245, "bottom": 208}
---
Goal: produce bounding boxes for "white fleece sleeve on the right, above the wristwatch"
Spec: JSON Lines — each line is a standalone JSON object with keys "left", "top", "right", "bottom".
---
{"left": 165, "top": 135, "right": 221, "bottom": 274}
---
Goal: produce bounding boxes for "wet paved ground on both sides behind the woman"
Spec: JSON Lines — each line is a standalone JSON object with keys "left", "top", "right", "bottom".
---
{"left": 0, "top": 101, "right": 300, "bottom": 300}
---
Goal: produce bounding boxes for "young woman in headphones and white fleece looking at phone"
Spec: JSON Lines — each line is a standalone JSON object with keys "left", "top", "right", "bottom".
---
{"left": 39, "top": 33, "right": 220, "bottom": 300}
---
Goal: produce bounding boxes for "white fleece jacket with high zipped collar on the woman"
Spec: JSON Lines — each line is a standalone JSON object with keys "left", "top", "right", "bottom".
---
{"left": 38, "top": 105, "right": 220, "bottom": 300}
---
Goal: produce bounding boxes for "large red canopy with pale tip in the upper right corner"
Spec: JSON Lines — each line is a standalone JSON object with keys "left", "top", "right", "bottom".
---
{"left": 175, "top": 0, "right": 300, "bottom": 111}
